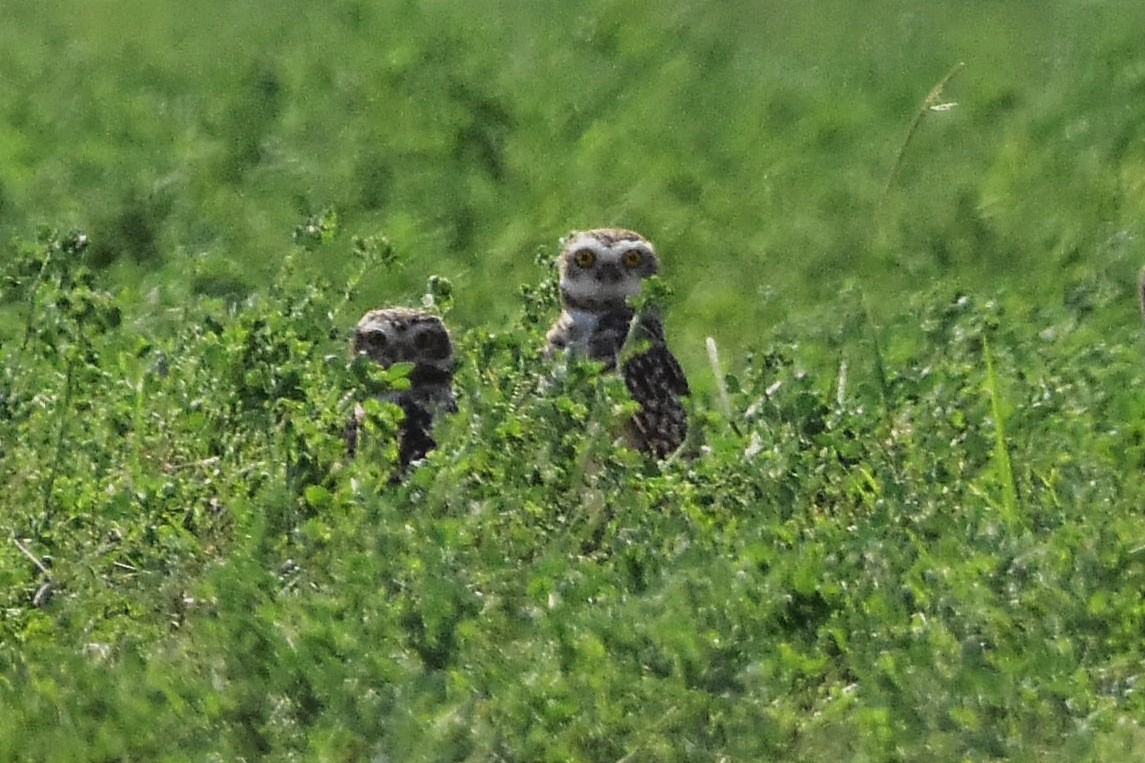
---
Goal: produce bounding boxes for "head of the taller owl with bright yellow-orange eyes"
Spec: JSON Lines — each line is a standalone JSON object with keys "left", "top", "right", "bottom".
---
{"left": 558, "top": 228, "right": 660, "bottom": 305}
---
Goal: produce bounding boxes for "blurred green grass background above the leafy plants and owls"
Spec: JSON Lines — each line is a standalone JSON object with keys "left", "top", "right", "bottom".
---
{"left": 0, "top": 0, "right": 1145, "bottom": 368}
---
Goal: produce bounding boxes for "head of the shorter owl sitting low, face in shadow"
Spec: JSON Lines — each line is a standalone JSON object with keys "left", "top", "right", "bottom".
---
{"left": 353, "top": 307, "right": 453, "bottom": 371}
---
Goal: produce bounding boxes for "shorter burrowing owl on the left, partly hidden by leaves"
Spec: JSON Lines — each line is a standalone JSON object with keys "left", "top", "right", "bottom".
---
{"left": 346, "top": 307, "right": 457, "bottom": 471}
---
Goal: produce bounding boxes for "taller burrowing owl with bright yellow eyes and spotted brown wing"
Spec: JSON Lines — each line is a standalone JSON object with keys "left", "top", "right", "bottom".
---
{"left": 545, "top": 228, "right": 689, "bottom": 458}
